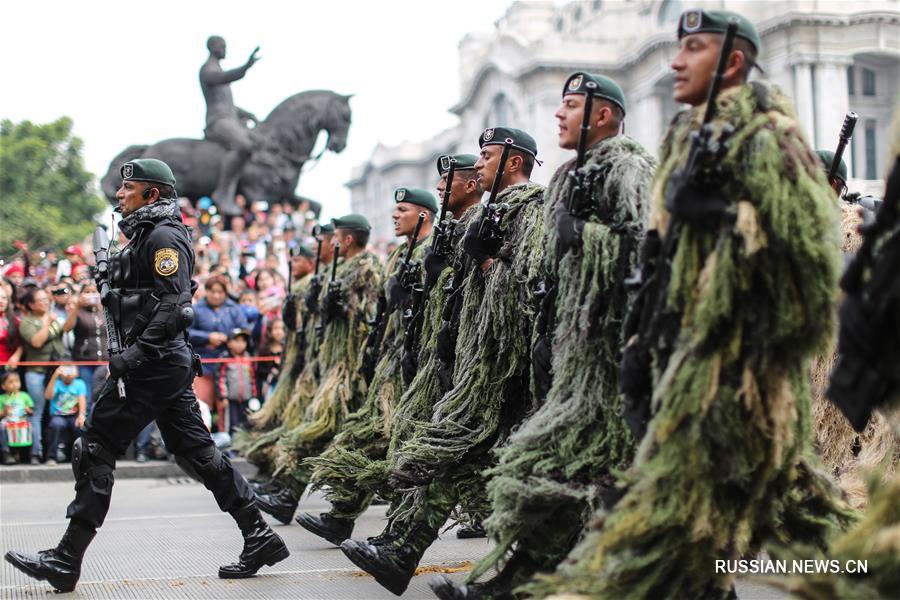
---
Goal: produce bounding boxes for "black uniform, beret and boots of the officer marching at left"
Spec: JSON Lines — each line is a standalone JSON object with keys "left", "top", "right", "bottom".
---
{"left": 4, "top": 183, "right": 289, "bottom": 592}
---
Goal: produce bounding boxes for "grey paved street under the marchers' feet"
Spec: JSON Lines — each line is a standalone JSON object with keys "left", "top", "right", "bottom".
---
{"left": 0, "top": 477, "right": 779, "bottom": 600}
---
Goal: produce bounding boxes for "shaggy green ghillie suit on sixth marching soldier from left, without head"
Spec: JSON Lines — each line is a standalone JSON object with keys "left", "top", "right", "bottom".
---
{"left": 395, "top": 183, "right": 544, "bottom": 518}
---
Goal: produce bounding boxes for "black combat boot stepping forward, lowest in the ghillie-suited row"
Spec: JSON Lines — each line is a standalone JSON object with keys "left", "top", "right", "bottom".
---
{"left": 341, "top": 524, "right": 437, "bottom": 596}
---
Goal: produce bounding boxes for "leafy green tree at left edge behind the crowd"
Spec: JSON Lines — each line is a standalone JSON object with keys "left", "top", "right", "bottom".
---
{"left": 0, "top": 117, "right": 105, "bottom": 256}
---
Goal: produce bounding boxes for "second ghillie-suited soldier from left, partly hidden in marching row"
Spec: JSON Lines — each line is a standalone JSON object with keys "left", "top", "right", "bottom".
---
{"left": 239, "top": 223, "right": 334, "bottom": 478}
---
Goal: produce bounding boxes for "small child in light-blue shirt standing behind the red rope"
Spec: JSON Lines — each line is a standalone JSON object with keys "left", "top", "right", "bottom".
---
{"left": 44, "top": 365, "right": 87, "bottom": 465}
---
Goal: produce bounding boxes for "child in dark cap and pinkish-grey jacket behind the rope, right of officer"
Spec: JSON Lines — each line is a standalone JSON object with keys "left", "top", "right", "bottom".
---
{"left": 217, "top": 329, "right": 256, "bottom": 434}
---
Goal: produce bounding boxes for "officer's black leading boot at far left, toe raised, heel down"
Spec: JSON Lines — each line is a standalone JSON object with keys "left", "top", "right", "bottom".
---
{"left": 4, "top": 521, "right": 97, "bottom": 592}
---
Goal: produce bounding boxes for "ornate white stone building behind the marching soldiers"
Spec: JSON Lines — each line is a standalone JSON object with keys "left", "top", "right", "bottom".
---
{"left": 346, "top": 0, "right": 900, "bottom": 240}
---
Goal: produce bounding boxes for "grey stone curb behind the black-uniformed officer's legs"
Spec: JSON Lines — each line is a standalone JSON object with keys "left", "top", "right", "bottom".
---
{"left": 0, "top": 458, "right": 256, "bottom": 484}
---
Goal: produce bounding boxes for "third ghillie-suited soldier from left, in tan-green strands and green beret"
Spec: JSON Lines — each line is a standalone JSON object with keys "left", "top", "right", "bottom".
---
{"left": 257, "top": 214, "right": 381, "bottom": 523}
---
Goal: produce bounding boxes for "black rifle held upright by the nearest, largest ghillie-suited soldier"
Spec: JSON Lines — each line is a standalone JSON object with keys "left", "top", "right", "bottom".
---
{"left": 619, "top": 19, "right": 738, "bottom": 439}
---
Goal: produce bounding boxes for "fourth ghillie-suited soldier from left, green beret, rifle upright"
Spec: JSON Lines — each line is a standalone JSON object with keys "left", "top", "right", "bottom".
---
{"left": 297, "top": 187, "right": 437, "bottom": 545}
